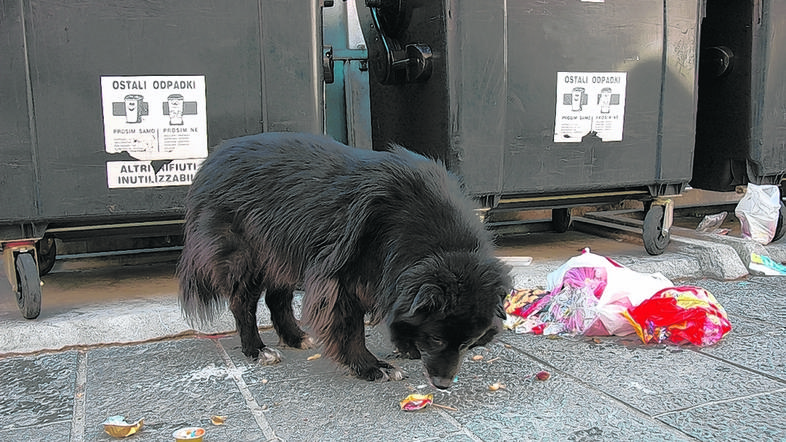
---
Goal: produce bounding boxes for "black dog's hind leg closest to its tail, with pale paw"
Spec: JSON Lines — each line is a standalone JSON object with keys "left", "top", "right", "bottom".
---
{"left": 229, "top": 284, "right": 281, "bottom": 365}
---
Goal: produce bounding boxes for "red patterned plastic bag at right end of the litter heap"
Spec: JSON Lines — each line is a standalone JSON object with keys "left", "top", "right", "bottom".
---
{"left": 623, "top": 286, "right": 731, "bottom": 345}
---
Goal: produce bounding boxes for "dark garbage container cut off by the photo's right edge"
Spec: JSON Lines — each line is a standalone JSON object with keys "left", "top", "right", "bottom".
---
{"left": 691, "top": 0, "right": 786, "bottom": 191}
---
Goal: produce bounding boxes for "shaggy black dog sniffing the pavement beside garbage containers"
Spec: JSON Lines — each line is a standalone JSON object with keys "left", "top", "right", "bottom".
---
{"left": 177, "top": 133, "right": 511, "bottom": 388}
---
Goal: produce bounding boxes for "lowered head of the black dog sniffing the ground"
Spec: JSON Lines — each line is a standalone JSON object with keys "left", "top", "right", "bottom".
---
{"left": 389, "top": 253, "right": 511, "bottom": 389}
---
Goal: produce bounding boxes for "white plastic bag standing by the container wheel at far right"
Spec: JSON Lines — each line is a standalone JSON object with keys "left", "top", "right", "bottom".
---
{"left": 734, "top": 183, "right": 781, "bottom": 245}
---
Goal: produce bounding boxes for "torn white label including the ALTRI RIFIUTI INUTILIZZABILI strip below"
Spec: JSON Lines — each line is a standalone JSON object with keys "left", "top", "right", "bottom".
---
{"left": 101, "top": 75, "right": 207, "bottom": 188}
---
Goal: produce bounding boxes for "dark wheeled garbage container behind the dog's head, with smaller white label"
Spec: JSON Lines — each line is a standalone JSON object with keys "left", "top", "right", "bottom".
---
{"left": 362, "top": 0, "right": 703, "bottom": 253}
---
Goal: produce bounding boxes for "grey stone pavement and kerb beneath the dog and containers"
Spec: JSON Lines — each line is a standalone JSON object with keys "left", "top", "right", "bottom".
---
{"left": 0, "top": 223, "right": 786, "bottom": 441}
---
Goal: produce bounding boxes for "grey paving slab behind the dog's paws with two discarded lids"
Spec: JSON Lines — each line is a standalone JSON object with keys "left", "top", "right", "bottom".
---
{"left": 82, "top": 339, "right": 266, "bottom": 441}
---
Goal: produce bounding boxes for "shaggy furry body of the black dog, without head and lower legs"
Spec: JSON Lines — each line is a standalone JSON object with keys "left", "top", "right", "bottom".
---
{"left": 177, "top": 133, "right": 504, "bottom": 334}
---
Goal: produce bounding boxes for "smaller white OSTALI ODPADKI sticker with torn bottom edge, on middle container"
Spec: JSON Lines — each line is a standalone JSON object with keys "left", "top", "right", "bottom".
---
{"left": 554, "top": 72, "right": 627, "bottom": 143}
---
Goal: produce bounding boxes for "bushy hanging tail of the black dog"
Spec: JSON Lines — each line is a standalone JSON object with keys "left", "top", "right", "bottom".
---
{"left": 177, "top": 228, "right": 227, "bottom": 325}
